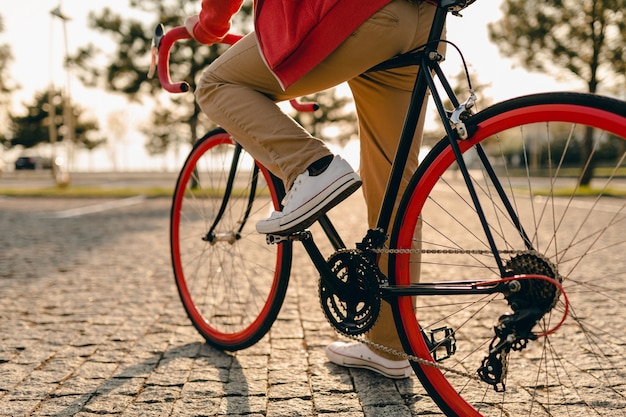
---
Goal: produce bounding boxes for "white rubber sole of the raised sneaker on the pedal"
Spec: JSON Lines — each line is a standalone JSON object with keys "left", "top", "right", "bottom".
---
{"left": 257, "top": 174, "right": 362, "bottom": 235}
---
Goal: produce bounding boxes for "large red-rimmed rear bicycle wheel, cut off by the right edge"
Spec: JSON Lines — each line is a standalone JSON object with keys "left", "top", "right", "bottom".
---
{"left": 391, "top": 93, "right": 626, "bottom": 417}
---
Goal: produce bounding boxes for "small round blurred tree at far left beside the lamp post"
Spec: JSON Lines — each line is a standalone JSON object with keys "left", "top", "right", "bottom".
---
{"left": 7, "top": 91, "right": 105, "bottom": 150}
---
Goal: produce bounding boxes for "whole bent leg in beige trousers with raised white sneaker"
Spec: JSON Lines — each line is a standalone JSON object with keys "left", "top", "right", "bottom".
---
{"left": 196, "top": 0, "right": 434, "bottom": 233}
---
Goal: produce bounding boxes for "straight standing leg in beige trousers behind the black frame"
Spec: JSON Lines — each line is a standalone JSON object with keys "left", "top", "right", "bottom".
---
{"left": 330, "top": 3, "right": 434, "bottom": 360}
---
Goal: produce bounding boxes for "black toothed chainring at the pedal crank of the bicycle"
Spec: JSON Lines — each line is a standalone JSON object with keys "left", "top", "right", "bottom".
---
{"left": 319, "top": 249, "right": 381, "bottom": 336}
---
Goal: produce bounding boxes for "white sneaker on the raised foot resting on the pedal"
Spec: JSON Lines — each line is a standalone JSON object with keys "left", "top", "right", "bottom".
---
{"left": 256, "top": 155, "right": 361, "bottom": 234}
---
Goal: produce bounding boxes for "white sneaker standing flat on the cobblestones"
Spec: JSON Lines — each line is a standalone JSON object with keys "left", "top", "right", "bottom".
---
{"left": 326, "top": 342, "right": 412, "bottom": 379}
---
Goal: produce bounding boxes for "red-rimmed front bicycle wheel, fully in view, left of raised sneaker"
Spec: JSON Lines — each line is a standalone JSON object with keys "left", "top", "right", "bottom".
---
{"left": 170, "top": 130, "right": 292, "bottom": 351}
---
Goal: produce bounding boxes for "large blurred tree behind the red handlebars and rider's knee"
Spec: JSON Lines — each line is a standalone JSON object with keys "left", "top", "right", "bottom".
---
{"left": 71, "top": 0, "right": 252, "bottom": 152}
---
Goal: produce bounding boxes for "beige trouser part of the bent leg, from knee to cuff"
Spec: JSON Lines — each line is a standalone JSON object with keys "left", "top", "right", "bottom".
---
{"left": 196, "top": 33, "right": 331, "bottom": 188}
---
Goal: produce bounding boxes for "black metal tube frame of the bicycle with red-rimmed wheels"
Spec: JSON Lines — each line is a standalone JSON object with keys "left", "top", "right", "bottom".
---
{"left": 224, "top": 2, "right": 530, "bottom": 298}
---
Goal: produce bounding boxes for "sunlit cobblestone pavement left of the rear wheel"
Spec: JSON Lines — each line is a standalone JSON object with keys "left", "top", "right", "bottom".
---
{"left": 0, "top": 197, "right": 441, "bottom": 417}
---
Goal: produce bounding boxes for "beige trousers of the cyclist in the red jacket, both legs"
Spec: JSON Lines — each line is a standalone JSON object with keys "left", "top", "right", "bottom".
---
{"left": 196, "top": 0, "right": 435, "bottom": 359}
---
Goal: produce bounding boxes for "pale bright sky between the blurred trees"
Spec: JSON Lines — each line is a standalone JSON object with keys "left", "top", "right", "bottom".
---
{"left": 0, "top": 0, "right": 571, "bottom": 171}
